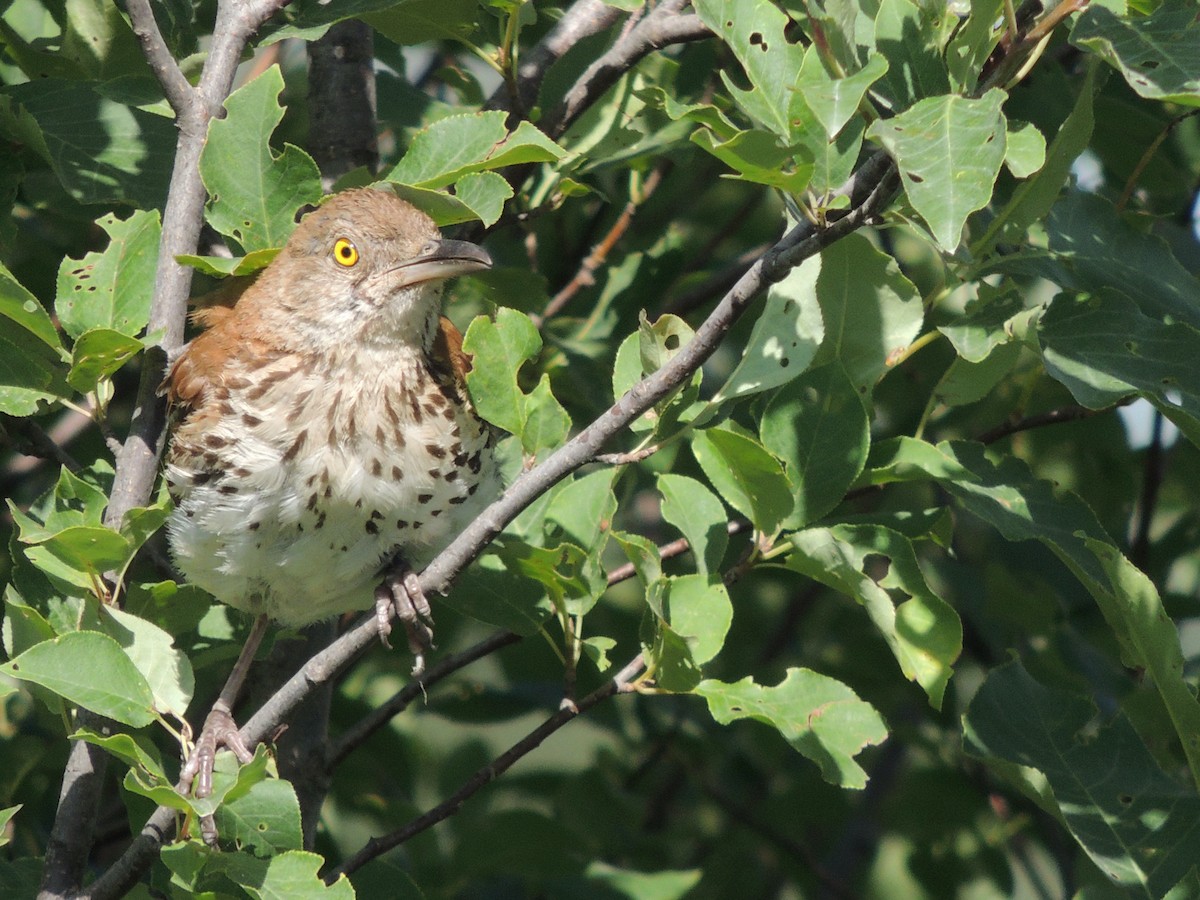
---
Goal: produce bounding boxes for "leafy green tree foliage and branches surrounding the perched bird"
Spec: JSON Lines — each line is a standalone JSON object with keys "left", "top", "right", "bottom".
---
{"left": 0, "top": 0, "right": 1200, "bottom": 898}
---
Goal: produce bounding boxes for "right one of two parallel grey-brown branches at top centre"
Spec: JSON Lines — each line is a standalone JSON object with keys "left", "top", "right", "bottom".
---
{"left": 538, "top": 0, "right": 713, "bottom": 138}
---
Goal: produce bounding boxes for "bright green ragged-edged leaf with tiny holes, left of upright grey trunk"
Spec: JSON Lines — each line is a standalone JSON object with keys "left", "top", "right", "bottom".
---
{"left": 54, "top": 210, "right": 162, "bottom": 337}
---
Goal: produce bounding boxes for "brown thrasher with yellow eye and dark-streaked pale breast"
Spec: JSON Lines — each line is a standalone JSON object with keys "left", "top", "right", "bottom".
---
{"left": 164, "top": 188, "right": 498, "bottom": 811}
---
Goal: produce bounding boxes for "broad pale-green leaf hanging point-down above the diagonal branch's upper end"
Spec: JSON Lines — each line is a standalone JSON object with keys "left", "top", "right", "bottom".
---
{"left": 866, "top": 89, "right": 1007, "bottom": 252}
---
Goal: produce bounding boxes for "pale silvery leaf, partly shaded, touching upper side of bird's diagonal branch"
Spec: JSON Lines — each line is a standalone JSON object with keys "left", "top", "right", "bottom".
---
{"left": 713, "top": 257, "right": 824, "bottom": 402}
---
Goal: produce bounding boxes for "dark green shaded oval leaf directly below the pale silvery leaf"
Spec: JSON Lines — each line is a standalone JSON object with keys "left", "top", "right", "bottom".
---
{"left": 761, "top": 365, "right": 871, "bottom": 527}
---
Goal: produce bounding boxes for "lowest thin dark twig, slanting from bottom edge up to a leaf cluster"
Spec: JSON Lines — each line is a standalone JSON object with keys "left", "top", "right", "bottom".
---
{"left": 325, "top": 654, "right": 646, "bottom": 884}
